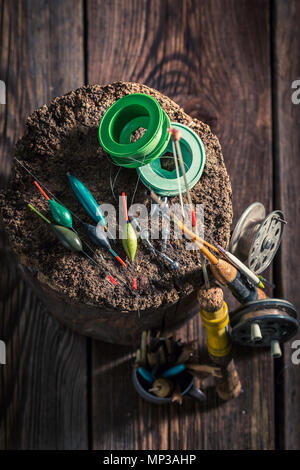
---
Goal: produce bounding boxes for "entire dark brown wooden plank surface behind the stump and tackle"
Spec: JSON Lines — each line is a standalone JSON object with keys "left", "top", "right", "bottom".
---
{"left": 0, "top": 0, "right": 300, "bottom": 449}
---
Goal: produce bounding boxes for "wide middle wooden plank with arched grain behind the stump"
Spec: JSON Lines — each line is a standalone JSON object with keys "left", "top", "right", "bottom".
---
{"left": 87, "top": 0, "right": 274, "bottom": 449}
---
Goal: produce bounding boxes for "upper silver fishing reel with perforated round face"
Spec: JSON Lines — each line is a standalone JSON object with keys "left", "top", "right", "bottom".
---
{"left": 229, "top": 202, "right": 286, "bottom": 274}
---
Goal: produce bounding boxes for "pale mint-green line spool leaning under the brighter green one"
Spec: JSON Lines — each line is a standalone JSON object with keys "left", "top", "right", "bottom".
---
{"left": 137, "top": 122, "right": 206, "bottom": 196}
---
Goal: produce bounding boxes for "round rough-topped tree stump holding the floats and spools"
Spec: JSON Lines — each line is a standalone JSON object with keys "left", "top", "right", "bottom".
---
{"left": 0, "top": 82, "right": 232, "bottom": 344}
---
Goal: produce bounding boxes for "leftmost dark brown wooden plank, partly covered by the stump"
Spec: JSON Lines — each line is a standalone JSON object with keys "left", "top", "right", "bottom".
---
{"left": 0, "top": 0, "right": 88, "bottom": 449}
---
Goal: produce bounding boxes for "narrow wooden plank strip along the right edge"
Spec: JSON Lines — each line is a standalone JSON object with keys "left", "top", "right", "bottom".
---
{"left": 273, "top": 0, "right": 300, "bottom": 449}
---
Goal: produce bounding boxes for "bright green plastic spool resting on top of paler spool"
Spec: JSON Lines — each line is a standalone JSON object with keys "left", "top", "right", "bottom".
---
{"left": 99, "top": 93, "right": 170, "bottom": 168}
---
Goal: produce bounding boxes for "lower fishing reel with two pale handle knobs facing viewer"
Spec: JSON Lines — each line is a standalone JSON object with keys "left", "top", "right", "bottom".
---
{"left": 230, "top": 298, "right": 298, "bottom": 358}
